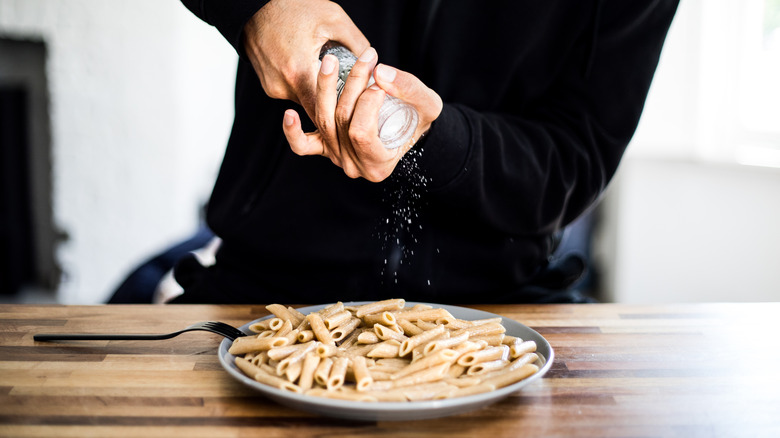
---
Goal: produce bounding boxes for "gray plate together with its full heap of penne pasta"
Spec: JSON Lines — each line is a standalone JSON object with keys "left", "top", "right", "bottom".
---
{"left": 219, "top": 299, "right": 554, "bottom": 421}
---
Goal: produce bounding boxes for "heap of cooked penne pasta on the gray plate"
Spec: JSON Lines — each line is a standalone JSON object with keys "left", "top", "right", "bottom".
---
{"left": 228, "top": 299, "right": 540, "bottom": 402}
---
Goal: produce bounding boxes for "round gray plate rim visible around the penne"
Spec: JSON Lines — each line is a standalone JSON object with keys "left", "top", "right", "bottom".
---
{"left": 219, "top": 302, "right": 554, "bottom": 421}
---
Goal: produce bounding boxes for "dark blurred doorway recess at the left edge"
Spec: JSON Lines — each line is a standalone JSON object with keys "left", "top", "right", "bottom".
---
{"left": 0, "top": 37, "right": 58, "bottom": 298}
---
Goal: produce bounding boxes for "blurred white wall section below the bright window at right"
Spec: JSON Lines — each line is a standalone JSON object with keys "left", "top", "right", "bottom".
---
{"left": 596, "top": 159, "right": 780, "bottom": 303}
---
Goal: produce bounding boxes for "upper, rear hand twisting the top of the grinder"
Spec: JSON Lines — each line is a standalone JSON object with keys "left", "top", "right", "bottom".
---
{"left": 244, "top": 0, "right": 369, "bottom": 120}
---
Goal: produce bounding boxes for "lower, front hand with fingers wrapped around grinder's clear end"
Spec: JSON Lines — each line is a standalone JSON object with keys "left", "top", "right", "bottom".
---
{"left": 283, "top": 48, "right": 443, "bottom": 182}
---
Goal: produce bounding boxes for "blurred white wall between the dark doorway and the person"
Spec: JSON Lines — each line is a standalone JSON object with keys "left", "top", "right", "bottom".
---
{"left": 0, "top": 0, "right": 236, "bottom": 303}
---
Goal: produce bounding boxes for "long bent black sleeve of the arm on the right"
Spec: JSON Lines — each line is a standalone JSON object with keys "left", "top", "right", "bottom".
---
{"left": 419, "top": 0, "right": 677, "bottom": 235}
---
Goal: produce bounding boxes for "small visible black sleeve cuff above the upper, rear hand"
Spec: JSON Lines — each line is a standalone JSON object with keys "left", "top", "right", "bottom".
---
{"left": 182, "top": 0, "right": 269, "bottom": 59}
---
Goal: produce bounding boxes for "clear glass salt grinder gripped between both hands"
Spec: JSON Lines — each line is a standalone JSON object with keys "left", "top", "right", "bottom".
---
{"left": 320, "top": 44, "right": 419, "bottom": 149}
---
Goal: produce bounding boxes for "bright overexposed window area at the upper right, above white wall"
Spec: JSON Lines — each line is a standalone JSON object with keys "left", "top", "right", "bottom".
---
{"left": 629, "top": 0, "right": 780, "bottom": 168}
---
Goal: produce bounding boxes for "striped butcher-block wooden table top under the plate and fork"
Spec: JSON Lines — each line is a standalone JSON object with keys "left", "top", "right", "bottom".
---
{"left": 0, "top": 303, "right": 780, "bottom": 438}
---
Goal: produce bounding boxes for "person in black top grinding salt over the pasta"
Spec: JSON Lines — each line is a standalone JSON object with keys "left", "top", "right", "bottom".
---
{"left": 172, "top": 0, "right": 678, "bottom": 304}
